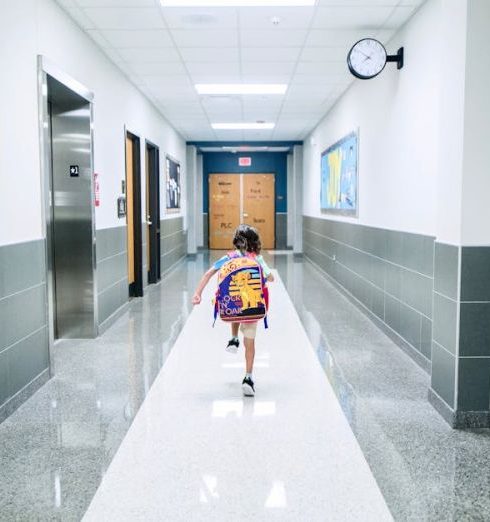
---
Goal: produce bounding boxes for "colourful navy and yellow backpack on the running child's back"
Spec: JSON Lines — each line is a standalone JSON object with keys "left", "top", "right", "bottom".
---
{"left": 214, "top": 252, "right": 268, "bottom": 328}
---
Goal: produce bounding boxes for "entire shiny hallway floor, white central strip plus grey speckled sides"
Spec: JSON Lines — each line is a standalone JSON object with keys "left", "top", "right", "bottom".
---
{"left": 0, "top": 253, "right": 490, "bottom": 521}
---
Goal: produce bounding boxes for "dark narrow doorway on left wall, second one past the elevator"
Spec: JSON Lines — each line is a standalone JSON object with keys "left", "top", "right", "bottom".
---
{"left": 145, "top": 140, "right": 162, "bottom": 284}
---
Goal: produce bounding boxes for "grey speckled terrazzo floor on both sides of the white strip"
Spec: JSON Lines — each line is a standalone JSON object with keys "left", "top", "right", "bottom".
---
{"left": 0, "top": 253, "right": 490, "bottom": 521}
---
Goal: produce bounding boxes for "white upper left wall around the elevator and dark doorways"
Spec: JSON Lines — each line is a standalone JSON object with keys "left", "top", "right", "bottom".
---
{"left": 0, "top": 0, "right": 186, "bottom": 245}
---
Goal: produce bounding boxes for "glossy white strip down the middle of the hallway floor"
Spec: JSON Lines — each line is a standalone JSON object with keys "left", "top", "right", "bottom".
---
{"left": 84, "top": 274, "right": 391, "bottom": 522}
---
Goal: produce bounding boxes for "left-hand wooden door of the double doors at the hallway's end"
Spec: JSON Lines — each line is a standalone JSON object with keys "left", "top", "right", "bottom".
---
{"left": 209, "top": 174, "right": 240, "bottom": 250}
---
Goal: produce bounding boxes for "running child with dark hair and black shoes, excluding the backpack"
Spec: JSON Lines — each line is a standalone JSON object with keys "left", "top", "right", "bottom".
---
{"left": 192, "top": 225, "right": 274, "bottom": 397}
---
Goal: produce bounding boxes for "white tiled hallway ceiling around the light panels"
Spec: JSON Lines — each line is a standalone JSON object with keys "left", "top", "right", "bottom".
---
{"left": 57, "top": 0, "right": 425, "bottom": 141}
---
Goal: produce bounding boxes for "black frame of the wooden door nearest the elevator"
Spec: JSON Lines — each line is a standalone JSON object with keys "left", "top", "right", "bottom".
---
{"left": 124, "top": 126, "right": 143, "bottom": 297}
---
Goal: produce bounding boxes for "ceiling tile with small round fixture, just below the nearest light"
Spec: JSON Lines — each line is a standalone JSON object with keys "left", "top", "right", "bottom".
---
{"left": 239, "top": 7, "right": 315, "bottom": 31}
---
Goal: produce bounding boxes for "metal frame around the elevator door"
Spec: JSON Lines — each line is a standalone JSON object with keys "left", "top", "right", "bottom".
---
{"left": 37, "top": 55, "right": 98, "bottom": 376}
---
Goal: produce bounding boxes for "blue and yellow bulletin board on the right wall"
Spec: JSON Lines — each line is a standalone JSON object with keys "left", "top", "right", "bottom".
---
{"left": 320, "top": 132, "right": 358, "bottom": 216}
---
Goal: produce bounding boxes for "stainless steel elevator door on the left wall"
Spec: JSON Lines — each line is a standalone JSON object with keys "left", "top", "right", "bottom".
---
{"left": 48, "top": 79, "right": 96, "bottom": 338}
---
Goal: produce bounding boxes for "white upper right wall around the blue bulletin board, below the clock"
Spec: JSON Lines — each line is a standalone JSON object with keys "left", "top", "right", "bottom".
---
{"left": 303, "top": 0, "right": 442, "bottom": 235}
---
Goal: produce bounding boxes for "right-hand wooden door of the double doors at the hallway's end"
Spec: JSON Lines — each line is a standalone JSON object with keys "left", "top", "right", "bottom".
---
{"left": 242, "top": 174, "right": 276, "bottom": 249}
